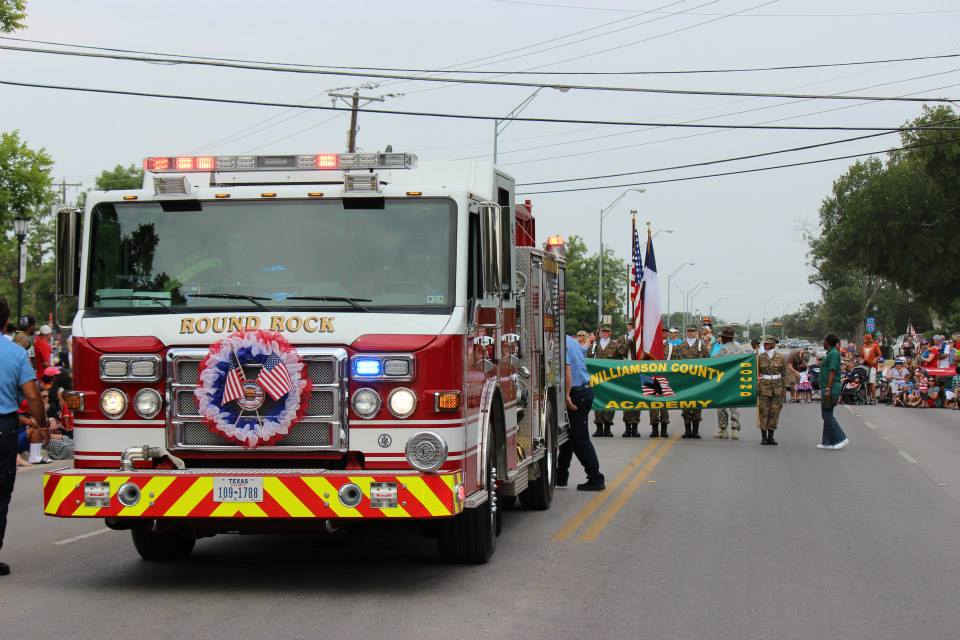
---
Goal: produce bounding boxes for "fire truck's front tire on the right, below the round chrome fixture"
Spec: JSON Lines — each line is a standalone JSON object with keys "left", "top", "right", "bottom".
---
{"left": 437, "top": 434, "right": 500, "bottom": 564}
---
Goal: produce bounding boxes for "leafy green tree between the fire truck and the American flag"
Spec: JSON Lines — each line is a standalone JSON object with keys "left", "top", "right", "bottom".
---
{"left": 566, "top": 236, "right": 627, "bottom": 335}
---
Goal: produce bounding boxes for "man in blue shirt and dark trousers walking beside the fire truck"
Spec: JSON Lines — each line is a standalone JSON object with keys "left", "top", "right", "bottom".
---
{"left": 557, "top": 336, "right": 607, "bottom": 491}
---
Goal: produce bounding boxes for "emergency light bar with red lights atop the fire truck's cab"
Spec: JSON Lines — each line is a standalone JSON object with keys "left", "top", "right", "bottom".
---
{"left": 143, "top": 153, "right": 417, "bottom": 173}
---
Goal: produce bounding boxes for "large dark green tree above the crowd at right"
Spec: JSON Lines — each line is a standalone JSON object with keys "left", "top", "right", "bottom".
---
{"left": 810, "top": 107, "right": 960, "bottom": 335}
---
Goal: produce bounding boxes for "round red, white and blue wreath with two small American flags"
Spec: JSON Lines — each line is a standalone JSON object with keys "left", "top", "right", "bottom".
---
{"left": 194, "top": 330, "right": 311, "bottom": 449}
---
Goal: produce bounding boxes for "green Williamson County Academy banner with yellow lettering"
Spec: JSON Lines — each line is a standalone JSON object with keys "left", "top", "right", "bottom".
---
{"left": 586, "top": 352, "right": 757, "bottom": 411}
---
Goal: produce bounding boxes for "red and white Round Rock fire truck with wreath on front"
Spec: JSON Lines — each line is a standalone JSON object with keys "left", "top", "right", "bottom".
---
{"left": 44, "top": 152, "right": 567, "bottom": 562}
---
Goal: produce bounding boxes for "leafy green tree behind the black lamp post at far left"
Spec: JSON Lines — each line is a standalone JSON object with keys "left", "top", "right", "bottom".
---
{"left": 0, "top": 131, "right": 54, "bottom": 317}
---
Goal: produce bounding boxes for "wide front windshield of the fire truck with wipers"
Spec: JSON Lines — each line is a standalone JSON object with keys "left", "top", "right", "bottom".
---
{"left": 86, "top": 198, "right": 457, "bottom": 314}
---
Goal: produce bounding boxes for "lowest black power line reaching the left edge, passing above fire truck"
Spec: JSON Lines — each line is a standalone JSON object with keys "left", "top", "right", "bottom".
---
{"left": 0, "top": 80, "right": 960, "bottom": 131}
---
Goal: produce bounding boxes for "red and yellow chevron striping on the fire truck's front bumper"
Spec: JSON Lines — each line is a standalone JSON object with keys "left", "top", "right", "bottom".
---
{"left": 43, "top": 470, "right": 463, "bottom": 519}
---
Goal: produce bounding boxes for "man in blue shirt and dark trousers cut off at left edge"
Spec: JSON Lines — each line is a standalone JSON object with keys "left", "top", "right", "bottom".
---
{"left": 0, "top": 298, "right": 50, "bottom": 576}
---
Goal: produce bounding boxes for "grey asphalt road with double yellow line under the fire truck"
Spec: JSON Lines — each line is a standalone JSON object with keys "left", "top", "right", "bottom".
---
{"left": 0, "top": 404, "right": 960, "bottom": 640}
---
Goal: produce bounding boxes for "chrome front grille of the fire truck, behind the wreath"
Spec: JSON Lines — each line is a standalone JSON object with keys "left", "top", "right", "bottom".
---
{"left": 167, "top": 348, "right": 348, "bottom": 451}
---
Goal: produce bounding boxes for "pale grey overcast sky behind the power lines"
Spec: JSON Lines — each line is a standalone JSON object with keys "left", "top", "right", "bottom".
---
{"left": 0, "top": 0, "right": 960, "bottom": 322}
